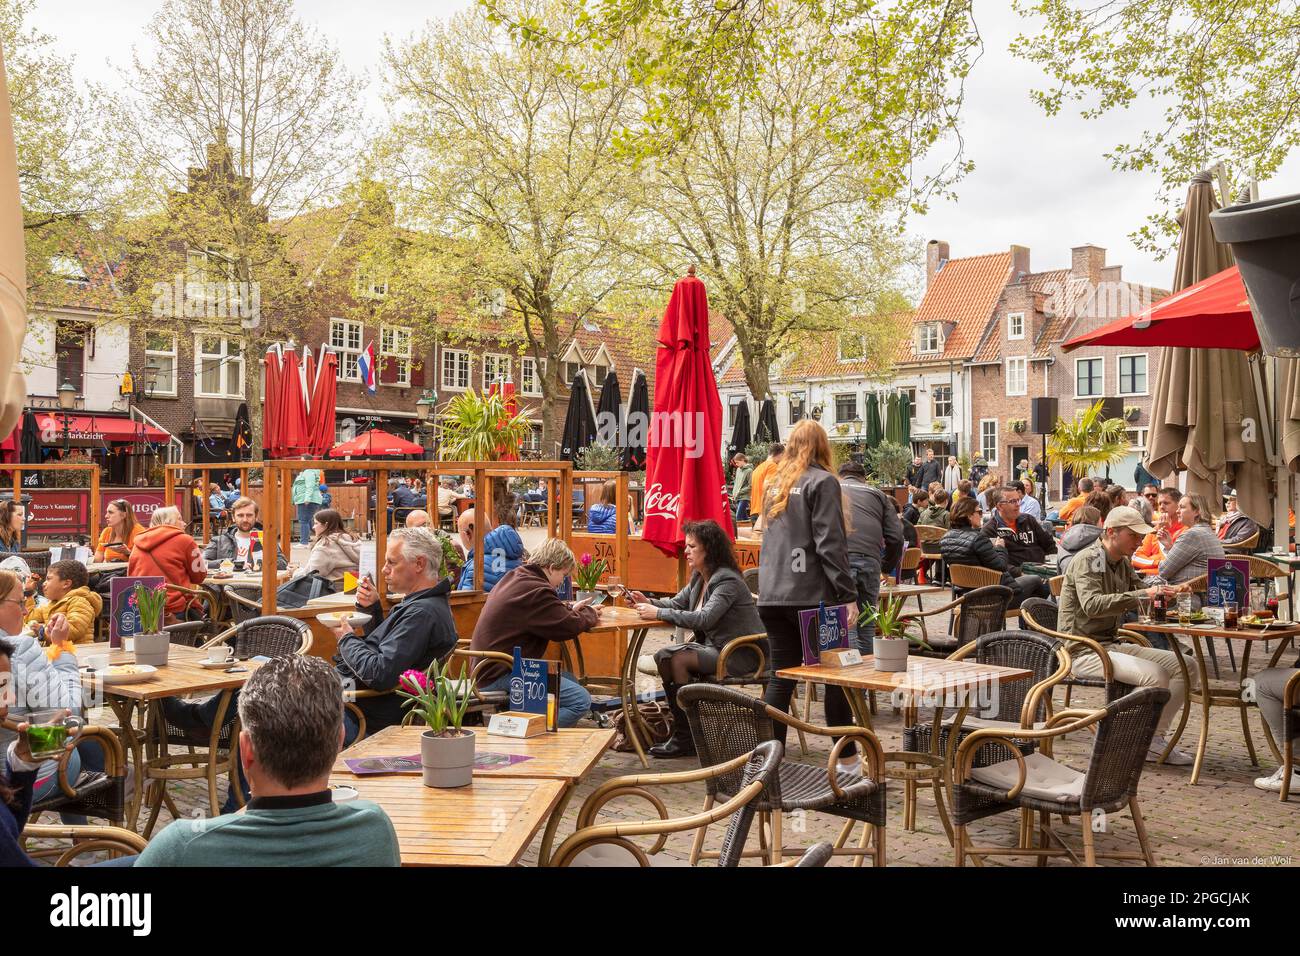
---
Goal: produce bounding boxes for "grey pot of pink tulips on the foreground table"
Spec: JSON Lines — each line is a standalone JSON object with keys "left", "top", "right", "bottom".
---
{"left": 398, "top": 661, "right": 475, "bottom": 790}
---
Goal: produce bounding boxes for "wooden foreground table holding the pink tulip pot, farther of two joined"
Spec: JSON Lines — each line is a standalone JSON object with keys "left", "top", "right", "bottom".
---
{"left": 330, "top": 727, "right": 614, "bottom": 866}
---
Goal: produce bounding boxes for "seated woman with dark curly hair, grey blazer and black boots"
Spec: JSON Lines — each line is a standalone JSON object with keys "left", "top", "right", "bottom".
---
{"left": 631, "top": 522, "right": 768, "bottom": 757}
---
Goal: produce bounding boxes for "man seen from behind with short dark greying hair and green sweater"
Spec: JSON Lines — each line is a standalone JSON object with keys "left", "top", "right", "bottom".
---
{"left": 135, "top": 654, "right": 402, "bottom": 866}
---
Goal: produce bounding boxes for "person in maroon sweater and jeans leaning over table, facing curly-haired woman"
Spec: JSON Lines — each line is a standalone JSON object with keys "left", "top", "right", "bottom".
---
{"left": 469, "top": 537, "right": 601, "bottom": 727}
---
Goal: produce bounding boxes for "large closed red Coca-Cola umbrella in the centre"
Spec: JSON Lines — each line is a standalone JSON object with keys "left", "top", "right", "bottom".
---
{"left": 642, "top": 269, "right": 731, "bottom": 555}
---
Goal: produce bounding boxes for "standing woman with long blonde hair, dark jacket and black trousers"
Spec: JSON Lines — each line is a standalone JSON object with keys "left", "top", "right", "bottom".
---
{"left": 758, "top": 419, "right": 859, "bottom": 773}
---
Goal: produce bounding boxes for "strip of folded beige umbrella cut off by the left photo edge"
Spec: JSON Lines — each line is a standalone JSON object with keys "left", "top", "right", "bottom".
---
{"left": 0, "top": 42, "right": 27, "bottom": 438}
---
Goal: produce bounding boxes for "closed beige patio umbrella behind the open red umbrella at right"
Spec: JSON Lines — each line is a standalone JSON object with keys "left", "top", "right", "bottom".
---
{"left": 1147, "top": 172, "right": 1271, "bottom": 525}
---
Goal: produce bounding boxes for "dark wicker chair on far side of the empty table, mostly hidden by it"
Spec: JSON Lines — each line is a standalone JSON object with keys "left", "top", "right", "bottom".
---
{"left": 902, "top": 631, "right": 1070, "bottom": 766}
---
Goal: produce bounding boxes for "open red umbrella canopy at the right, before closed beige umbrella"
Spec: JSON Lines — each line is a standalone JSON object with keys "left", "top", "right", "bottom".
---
{"left": 1062, "top": 265, "right": 1260, "bottom": 351}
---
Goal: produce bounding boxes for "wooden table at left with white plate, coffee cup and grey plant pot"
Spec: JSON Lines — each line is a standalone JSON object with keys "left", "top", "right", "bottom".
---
{"left": 73, "top": 641, "right": 261, "bottom": 831}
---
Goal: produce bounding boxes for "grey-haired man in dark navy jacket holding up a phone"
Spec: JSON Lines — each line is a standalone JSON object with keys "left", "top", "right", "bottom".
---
{"left": 334, "top": 528, "right": 456, "bottom": 744}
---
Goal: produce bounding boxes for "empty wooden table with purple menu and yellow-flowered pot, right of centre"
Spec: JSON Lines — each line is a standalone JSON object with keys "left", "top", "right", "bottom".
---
{"left": 776, "top": 656, "right": 1034, "bottom": 842}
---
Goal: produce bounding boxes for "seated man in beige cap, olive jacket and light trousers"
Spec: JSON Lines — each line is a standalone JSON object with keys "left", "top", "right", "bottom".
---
{"left": 1060, "top": 505, "right": 1192, "bottom": 766}
